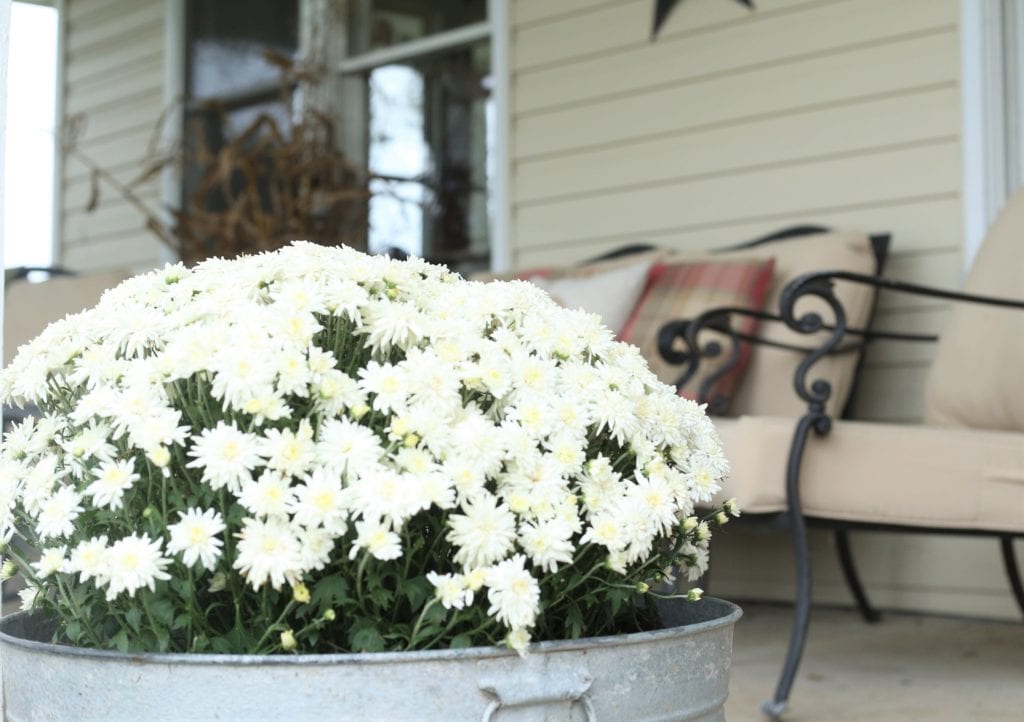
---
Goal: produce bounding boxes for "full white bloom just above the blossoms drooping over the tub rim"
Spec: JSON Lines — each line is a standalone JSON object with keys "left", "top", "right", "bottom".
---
{"left": 445, "top": 494, "right": 516, "bottom": 568}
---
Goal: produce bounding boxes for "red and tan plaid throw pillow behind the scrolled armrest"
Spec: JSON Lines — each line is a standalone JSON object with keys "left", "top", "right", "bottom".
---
{"left": 620, "top": 258, "right": 774, "bottom": 413}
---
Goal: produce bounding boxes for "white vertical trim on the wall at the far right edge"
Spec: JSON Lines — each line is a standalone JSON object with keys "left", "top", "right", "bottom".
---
{"left": 961, "top": 0, "right": 1024, "bottom": 271}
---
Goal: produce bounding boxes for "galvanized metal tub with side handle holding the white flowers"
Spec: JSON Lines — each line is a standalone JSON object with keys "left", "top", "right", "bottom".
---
{"left": 0, "top": 598, "right": 741, "bottom": 722}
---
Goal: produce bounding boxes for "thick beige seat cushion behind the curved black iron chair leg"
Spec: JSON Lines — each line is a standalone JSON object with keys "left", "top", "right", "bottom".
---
{"left": 715, "top": 417, "right": 1024, "bottom": 533}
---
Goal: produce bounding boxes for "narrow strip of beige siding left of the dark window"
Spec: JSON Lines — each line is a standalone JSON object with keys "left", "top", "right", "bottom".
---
{"left": 57, "top": 0, "right": 165, "bottom": 271}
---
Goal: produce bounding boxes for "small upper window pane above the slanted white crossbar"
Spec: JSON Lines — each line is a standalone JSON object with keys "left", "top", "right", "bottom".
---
{"left": 348, "top": 0, "right": 487, "bottom": 55}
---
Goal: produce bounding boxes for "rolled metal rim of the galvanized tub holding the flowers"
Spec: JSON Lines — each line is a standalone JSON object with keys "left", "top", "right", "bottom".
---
{"left": 0, "top": 597, "right": 742, "bottom": 666}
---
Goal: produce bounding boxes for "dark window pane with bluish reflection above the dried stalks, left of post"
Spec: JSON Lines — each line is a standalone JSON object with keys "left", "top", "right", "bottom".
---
{"left": 187, "top": 0, "right": 299, "bottom": 98}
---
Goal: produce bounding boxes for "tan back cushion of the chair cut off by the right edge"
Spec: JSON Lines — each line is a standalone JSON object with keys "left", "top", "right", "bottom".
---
{"left": 925, "top": 190, "right": 1024, "bottom": 431}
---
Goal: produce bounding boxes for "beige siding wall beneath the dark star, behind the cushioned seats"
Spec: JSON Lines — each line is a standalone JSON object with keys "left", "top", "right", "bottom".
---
{"left": 509, "top": 0, "right": 1017, "bottom": 618}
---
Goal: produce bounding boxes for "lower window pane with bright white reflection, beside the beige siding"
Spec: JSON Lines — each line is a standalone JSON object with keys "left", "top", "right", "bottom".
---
{"left": 368, "top": 43, "right": 493, "bottom": 269}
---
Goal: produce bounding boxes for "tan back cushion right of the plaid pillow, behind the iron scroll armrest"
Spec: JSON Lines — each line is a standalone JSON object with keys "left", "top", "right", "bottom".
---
{"left": 715, "top": 231, "right": 877, "bottom": 417}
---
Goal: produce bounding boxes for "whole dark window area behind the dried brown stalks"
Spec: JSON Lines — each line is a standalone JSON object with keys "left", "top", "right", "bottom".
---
{"left": 182, "top": 0, "right": 500, "bottom": 271}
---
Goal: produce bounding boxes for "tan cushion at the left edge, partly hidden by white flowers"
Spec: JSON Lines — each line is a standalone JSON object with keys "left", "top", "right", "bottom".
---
{"left": 3, "top": 272, "right": 129, "bottom": 366}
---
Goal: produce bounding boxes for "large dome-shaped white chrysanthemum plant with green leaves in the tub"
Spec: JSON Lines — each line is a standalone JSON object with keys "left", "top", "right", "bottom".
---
{"left": 0, "top": 243, "right": 734, "bottom": 653}
